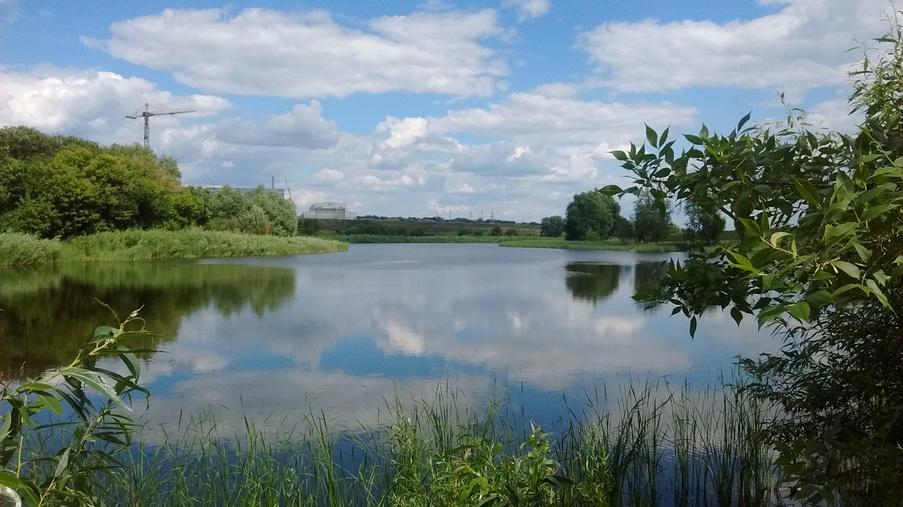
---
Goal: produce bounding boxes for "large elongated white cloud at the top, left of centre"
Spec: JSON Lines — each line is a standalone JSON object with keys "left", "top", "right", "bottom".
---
{"left": 95, "top": 9, "right": 508, "bottom": 98}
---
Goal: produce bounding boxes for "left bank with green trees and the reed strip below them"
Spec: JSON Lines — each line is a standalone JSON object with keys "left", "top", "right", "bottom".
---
{"left": 0, "top": 127, "right": 347, "bottom": 266}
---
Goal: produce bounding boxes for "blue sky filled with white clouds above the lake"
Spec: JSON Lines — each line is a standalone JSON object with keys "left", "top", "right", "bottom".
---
{"left": 0, "top": 0, "right": 890, "bottom": 221}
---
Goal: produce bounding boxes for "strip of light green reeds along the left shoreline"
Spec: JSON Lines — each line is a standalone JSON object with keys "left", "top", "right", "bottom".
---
{"left": 0, "top": 229, "right": 348, "bottom": 266}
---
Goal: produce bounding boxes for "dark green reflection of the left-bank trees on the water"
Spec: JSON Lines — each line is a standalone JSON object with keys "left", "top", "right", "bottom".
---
{"left": 0, "top": 263, "right": 295, "bottom": 379}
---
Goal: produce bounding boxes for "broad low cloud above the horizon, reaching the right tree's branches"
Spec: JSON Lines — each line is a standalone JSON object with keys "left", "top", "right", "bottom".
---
{"left": 372, "top": 85, "right": 697, "bottom": 187}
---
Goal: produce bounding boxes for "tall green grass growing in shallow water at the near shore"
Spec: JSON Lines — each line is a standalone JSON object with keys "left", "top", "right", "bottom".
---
{"left": 90, "top": 383, "right": 779, "bottom": 506}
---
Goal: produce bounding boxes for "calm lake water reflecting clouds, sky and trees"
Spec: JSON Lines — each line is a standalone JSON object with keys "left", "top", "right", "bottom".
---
{"left": 0, "top": 244, "right": 775, "bottom": 429}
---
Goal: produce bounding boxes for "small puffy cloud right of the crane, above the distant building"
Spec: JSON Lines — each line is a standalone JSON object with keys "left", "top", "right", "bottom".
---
{"left": 218, "top": 100, "right": 339, "bottom": 149}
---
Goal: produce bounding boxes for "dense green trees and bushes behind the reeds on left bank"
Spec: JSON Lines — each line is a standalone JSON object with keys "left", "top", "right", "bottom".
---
{"left": 0, "top": 127, "right": 297, "bottom": 238}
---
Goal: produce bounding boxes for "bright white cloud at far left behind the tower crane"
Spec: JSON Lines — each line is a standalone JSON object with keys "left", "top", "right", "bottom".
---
{"left": 0, "top": 66, "right": 229, "bottom": 143}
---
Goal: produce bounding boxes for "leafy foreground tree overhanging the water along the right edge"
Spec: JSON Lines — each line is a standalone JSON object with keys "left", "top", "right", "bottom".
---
{"left": 606, "top": 26, "right": 903, "bottom": 505}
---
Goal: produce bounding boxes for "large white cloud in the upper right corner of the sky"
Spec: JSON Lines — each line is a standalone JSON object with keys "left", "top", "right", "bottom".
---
{"left": 578, "top": 0, "right": 887, "bottom": 94}
